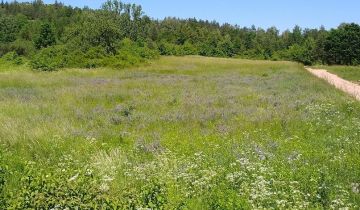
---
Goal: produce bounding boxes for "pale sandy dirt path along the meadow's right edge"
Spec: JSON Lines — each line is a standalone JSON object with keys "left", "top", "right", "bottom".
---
{"left": 306, "top": 68, "right": 360, "bottom": 101}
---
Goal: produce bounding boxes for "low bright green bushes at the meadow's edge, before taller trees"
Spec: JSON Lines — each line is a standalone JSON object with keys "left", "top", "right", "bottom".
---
{"left": 31, "top": 39, "right": 159, "bottom": 71}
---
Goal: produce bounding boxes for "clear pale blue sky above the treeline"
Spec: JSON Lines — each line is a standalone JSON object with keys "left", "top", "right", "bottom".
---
{"left": 13, "top": 0, "right": 360, "bottom": 31}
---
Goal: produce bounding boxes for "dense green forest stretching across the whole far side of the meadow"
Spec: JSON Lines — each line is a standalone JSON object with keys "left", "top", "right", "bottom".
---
{"left": 0, "top": 0, "right": 360, "bottom": 70}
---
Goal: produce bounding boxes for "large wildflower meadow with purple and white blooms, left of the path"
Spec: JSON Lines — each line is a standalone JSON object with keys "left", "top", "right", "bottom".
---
{"left": 0, "top": 57, "right": 360, "bottom": 209}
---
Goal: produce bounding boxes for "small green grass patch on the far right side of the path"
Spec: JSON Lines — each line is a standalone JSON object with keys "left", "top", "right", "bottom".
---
{"left": 318, "top": 66, "right": 360, "bottom": 84}
